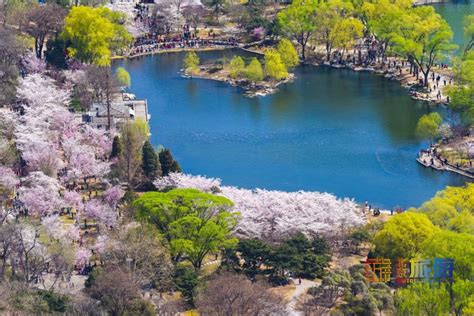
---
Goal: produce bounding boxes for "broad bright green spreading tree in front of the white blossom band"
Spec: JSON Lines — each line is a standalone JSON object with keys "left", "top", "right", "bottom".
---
{"left": 134, "top": 189, "right": 238, "bottom": 269}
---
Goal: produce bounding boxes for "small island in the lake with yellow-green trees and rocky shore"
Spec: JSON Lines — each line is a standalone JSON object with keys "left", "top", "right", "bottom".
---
{"left": 183, "top": 39, "right": 299, "bottom": 97}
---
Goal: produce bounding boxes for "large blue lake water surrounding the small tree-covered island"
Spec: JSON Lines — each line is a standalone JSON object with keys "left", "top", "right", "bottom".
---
{"left": 114, "top": 4, "right": 472, "bottom": 208}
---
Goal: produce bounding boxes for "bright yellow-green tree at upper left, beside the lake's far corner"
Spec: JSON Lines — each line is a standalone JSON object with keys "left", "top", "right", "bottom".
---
{"left": 62, "top": 6, "right": 132, "bottom": 66}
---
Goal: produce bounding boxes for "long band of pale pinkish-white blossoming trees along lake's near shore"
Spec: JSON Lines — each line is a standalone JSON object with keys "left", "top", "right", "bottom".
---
{"left": 154, "top": 173, "right": 364, "bottom": 238}
